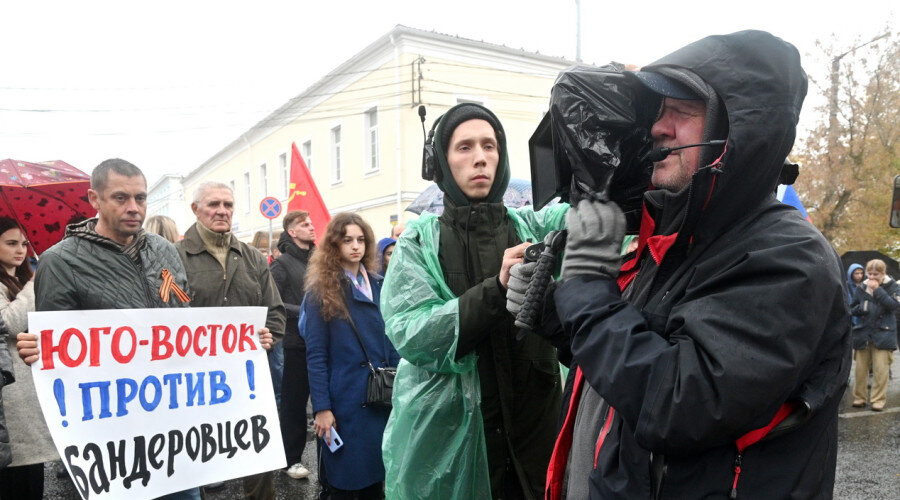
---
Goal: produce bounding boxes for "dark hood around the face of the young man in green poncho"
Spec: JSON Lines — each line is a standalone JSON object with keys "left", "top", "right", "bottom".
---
{"left": 434, "top": 102, "right": 510, "bottom": 206}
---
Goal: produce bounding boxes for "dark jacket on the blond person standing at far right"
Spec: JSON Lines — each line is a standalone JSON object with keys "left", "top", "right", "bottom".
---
{"left": 850, "top": 276, "right": 900, "bottom": 351}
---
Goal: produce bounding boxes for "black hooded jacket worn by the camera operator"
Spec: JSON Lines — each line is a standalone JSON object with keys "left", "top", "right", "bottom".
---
{"left": 551, "top": 31, "right": 850, "bottom": 499}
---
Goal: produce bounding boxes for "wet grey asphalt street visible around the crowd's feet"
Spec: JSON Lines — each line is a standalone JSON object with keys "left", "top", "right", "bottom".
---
{"left": 44, "top": 351, "right": 900, "bottom": 500}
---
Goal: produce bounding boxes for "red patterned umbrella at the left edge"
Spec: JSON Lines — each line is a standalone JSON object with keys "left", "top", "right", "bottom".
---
{"left": 0, "top": 160, "right": 97, "bottom": 254}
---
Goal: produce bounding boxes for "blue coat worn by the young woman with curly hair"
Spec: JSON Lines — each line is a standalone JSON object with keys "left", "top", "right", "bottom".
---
{"left": 299, "top": 273, "right": 400, "bottom": 490}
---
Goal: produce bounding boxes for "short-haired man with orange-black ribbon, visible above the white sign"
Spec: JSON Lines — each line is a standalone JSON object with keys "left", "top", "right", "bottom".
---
{"left": 35, "top": 159, "right": 190, "bottom": 311}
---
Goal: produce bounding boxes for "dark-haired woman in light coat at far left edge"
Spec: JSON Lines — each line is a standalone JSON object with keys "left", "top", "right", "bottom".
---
{"left": 0, "top": 217, "right": 59, "bottom": 499}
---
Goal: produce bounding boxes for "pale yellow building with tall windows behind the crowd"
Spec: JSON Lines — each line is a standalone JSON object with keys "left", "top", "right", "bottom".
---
{"left": 172, "top": 26, "right": 573, "bottom": 241}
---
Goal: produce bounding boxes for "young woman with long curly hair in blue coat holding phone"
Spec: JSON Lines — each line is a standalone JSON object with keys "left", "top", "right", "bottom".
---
{"left": 300, "top": 213, "right": 400, "bottom": 499}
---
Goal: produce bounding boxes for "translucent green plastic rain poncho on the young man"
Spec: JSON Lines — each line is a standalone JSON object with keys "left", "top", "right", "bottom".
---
{"left": 381, "top": 204, "right": 568, "bottom": 499}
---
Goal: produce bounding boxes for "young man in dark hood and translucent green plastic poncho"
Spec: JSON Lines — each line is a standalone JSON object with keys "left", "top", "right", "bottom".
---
{"left": 381, "top": 103, "right": 568, "bottom": 499}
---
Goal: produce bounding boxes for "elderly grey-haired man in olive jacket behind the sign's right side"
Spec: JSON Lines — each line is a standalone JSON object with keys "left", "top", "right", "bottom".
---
{"left": 175, "top": 182, "right": 285, "bottom": 499}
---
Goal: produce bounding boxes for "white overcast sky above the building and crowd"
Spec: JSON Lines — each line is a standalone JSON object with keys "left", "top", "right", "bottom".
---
{"left": 0, "top": 0, "right": 897, "bottom": 183}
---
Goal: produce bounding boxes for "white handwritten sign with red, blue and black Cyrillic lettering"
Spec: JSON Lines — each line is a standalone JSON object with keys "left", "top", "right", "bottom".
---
{"left": 28, "top": 307, "right": 285, "bottom": 499}
